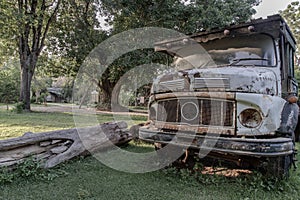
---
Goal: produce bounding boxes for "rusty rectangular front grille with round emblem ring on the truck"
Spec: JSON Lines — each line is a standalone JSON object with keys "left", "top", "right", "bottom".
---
{"left": 157, "top": 99, "right": 234, "bottom": 126}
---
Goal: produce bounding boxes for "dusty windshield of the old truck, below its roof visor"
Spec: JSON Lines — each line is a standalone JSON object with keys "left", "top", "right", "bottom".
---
{"left": 174, "top": 34, "right": 276, "bottom": 69}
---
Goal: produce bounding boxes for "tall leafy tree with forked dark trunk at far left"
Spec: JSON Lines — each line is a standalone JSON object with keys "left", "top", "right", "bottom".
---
{"left": 0, "top": 0, "right": 61, "bottom": 111}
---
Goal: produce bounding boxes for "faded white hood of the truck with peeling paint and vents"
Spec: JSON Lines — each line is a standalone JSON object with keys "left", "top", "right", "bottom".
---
{"left": 157, "top": 66, "right": 277, "bottom": 95}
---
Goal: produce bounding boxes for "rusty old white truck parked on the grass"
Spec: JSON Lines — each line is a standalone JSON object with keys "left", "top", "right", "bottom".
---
{"left": 139, "top": 15, "right": 298, "bottom": 176}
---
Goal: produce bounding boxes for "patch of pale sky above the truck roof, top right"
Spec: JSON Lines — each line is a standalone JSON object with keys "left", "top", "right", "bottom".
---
{"left": 254, "top": 0, "right": 299, "bottom": 18}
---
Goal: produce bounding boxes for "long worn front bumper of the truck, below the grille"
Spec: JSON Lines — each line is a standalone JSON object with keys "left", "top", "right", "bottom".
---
{"left": 139, "top": 126, "right": 293, "bottom": 157}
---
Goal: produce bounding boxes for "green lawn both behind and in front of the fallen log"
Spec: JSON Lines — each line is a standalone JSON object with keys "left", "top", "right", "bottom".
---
{"left": 0, "top": 110, "right": 300, "bottom": 200}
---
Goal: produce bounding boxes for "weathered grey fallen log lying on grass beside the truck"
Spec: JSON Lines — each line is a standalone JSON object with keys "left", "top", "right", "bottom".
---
{"left": 0, "top": 122, "right": 132, "bottom": 168}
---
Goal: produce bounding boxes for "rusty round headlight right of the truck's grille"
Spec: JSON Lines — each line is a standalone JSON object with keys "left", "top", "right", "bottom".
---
{"left": 239, "top": 108, "right": 262, "bottom": 128}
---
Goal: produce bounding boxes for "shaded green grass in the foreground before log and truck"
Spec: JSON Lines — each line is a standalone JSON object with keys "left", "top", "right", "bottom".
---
{"left": 0, "top": 143, "right": 300, "bottom": 200}
